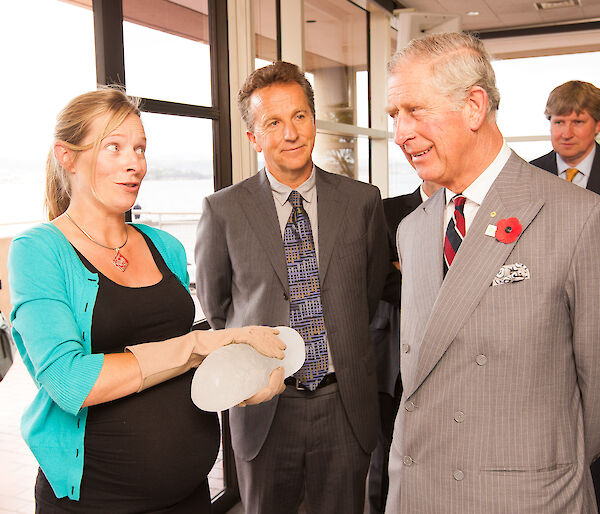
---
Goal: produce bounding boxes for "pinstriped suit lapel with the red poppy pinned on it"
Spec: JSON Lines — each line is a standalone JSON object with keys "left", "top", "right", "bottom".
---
{"left": 407, "top": 154, "right": 543, "bottom": 396}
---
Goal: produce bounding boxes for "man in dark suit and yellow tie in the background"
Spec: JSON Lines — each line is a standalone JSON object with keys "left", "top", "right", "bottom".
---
{"left": 531, "top": 80, "right": 600, "bottom": 193}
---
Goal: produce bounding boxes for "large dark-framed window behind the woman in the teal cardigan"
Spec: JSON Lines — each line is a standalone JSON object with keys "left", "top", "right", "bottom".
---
{"left": 0, "top": 0, "right": 235, "bottom": 513}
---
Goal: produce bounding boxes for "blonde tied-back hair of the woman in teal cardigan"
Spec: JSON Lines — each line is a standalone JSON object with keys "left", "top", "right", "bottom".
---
{"left": 45, "top": 86, "right": 140, "bottom": 220}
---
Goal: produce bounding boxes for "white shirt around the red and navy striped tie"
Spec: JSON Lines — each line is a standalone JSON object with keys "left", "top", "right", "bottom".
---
{"left": 442, "top": 143, "right": 510, "bottom": 236}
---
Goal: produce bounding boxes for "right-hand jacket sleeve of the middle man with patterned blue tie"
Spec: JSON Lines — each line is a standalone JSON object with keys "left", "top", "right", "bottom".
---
{"left": 367, "top": 186, "right": 390, "bottom": 320}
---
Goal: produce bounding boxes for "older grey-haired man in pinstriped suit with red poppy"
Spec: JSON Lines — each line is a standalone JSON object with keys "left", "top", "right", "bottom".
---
{"left": 386, "top": 34, "right": 600, "bottom": 514}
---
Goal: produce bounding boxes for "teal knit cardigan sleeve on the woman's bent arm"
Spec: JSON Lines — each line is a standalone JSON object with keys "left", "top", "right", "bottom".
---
{"left": 8, "top": 230, "right": 104, "bottom": 414}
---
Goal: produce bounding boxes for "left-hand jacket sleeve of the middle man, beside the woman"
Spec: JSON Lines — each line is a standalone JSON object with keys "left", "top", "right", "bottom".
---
{"left": 194, "top": 198, "right": 232, "bottom": 329}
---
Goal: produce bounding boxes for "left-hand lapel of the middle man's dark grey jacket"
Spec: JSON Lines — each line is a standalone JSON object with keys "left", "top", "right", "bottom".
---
{"left": 240, "top": 169, "right": 288, "bottom": 291}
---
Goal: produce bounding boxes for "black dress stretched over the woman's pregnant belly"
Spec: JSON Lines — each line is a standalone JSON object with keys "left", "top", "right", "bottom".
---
{"left": 35, "top": 229, "right": 220, "bottom": 514}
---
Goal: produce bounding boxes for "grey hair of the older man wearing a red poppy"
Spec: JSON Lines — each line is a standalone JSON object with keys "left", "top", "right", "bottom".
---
{"left": 388, "top": 32, "right": 500, "bottom": 117}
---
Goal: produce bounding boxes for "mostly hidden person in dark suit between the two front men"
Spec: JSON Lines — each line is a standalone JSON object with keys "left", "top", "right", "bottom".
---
{"left": 368, "top": 182, "right": 440, "bottom": 514}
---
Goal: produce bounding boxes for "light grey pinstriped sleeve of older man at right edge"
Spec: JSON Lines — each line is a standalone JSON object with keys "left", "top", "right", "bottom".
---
{"left": 567, "top": 199, "right": 600, "bottom": 462}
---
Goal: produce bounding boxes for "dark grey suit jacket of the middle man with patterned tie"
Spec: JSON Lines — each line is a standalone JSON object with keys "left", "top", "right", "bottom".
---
{"left": 195, "top": 168, "right": 388, "bottom": 460}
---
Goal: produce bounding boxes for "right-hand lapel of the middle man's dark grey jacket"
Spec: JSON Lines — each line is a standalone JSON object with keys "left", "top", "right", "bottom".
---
{"left": 313, "top": 166, "right": 348, "bottom": 284}
